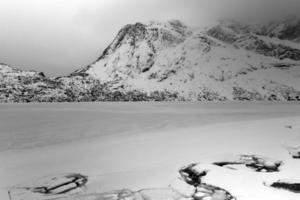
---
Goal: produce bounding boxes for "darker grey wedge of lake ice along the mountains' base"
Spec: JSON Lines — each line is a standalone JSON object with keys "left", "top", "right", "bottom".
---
{"left": 0, "top": 102, "right": 300, "bottom": 151}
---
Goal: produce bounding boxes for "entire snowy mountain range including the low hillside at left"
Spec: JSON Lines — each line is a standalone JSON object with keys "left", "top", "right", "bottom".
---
{"left": 0, "top": 19, "right": 300, "bottom": 101}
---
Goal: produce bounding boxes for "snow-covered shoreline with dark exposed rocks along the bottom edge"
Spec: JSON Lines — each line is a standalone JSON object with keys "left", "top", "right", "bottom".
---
{"left": 8, "top": 155, "right": 300, "bottom": 200}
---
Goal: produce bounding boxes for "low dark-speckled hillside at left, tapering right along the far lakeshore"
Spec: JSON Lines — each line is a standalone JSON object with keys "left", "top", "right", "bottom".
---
{"left": 0, "top": 64, "right": 162, "bottom": 102}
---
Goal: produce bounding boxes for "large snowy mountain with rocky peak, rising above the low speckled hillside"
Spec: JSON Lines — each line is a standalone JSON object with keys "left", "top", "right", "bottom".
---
{"left": 71, "top": 21, "right": 300, "bottom": 100}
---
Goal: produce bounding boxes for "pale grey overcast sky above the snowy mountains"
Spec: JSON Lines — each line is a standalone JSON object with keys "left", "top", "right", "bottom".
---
{"left": 0, "top": 0, "right": 300, "bottom": 75}
